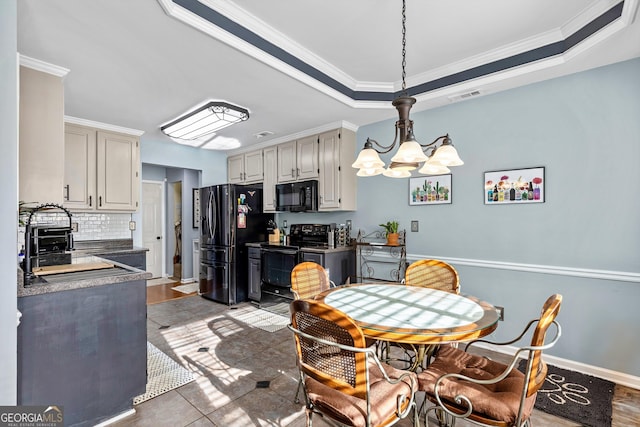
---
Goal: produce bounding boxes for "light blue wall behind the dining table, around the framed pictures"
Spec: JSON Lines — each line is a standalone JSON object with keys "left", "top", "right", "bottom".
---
{"left": 278, "top": 59, "right": 640, "bottom": 376}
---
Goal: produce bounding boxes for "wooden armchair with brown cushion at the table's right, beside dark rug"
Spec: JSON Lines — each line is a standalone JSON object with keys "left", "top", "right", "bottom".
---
{"left": 418, "top": 294, "right": 562, "bottom": 427}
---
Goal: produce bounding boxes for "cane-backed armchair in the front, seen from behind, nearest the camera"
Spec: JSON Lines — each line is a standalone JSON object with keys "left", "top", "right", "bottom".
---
{"left": 289, "top": 300, "right": 419, "bottom": 426}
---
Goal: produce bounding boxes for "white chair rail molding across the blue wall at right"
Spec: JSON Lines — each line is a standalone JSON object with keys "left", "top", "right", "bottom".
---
{"left": 407, "top": 254, "right": 640, "bottom": 283}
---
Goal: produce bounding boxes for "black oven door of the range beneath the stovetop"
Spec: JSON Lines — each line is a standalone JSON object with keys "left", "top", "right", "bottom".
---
{"left": 261, "top": 248, "right": 299, "bottom": 299}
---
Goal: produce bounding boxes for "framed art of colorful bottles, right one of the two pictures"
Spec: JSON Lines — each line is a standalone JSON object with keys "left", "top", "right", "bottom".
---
{"left": 484, "top": 167, "right": 545, "bottom": 205}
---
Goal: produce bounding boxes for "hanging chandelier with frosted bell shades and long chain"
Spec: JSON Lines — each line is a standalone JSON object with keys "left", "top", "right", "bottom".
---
{"left": 351, "top": 0, "right": 464, "bottom": 178}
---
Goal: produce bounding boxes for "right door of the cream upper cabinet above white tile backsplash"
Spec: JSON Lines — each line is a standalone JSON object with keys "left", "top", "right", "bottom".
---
{"left": 96, "top": 131, "right": 140, "bottom": 211}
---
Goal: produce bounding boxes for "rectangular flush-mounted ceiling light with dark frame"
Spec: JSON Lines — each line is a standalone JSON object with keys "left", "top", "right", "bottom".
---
{"left": 160, "top": 101, "right": 249, "bottom": 148}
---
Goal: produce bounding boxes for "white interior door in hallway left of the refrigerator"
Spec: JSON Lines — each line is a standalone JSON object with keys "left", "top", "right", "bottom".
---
{"left": 142, "top": 181, "right": 165, "bottom": 277}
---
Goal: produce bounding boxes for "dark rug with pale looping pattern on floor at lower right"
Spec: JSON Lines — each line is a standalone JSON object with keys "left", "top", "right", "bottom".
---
{"left": 518, "top": 360, "right": 615, "bottom": 427}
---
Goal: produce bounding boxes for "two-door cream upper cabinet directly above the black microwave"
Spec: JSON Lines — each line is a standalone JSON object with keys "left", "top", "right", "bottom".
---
{"left": 277, "top": 135, "right": 319, "bottom": 183}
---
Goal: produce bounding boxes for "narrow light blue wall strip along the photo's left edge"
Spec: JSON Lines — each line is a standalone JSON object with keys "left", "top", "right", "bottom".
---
{"left": 0, "top": 0, "right": 18, "bottom": 406}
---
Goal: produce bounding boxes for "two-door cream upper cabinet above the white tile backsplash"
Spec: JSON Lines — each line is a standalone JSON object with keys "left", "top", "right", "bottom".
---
{"left": 64, "top": 123, "right": 140, "bottom": 212}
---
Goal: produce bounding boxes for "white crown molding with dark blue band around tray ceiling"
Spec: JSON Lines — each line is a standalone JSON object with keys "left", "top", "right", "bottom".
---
{"left": 158, "top": 0, "right": 639, "bottom": 108}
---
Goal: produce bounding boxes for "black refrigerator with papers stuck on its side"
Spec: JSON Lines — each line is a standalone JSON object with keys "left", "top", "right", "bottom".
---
{"left": 199, "top": 184, "right": 273, "bottom": 305}
